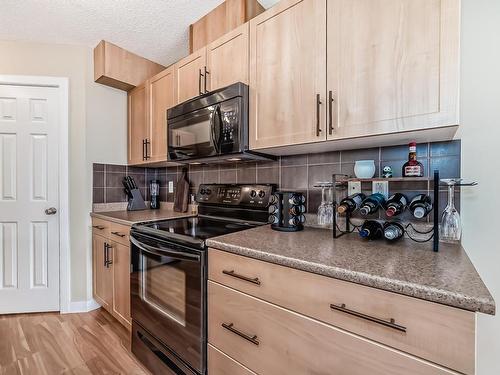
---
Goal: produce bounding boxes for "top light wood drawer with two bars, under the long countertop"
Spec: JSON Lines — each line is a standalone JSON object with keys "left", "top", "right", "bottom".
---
{"left": 209, "top": 249, "right": 475, "bottom": 374}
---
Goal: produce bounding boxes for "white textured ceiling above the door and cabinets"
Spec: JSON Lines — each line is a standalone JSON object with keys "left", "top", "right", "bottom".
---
{"left": 0, "top": 0, "right": 278, "bottom": 65}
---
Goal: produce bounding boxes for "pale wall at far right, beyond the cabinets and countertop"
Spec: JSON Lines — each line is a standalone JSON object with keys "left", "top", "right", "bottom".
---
{"left": 461, "top": 0, "right": 500, "bottom": 375}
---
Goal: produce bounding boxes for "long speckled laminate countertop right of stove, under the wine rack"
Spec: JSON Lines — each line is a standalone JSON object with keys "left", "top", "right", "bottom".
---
{"left": 207, "top": 226, "right": 495, "bottom": 315}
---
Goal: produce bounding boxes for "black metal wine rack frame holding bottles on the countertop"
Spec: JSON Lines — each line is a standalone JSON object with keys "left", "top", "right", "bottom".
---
{"left": 332, "top": 170, "right": 442, "bottom": 252}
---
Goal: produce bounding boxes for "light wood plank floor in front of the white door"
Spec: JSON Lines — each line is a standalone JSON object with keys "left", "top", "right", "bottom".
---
{"left": 0, "top": 309, "right": 149, "bottom": 375}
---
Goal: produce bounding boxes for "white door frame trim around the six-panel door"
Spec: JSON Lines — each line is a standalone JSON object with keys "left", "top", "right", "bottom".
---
{"left": 0, "top": 75, "right": 71, "bottom": 313}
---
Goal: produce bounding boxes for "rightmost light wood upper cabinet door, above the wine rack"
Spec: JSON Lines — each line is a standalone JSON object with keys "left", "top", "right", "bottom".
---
{"left": 327, "top": 0, "right": 460, "bottom": 139}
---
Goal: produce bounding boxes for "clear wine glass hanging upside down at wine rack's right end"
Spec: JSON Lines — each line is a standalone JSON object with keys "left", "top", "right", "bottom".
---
{"left": 439, "top": 178, "right": 462, "bottom": 242}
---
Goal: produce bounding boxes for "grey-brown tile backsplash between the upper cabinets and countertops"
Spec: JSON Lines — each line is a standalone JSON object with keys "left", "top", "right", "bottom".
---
{"left": 93, "top": 141, "right": 460, "bottom": 217}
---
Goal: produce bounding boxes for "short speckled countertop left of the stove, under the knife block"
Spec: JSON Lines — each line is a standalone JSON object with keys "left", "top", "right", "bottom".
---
{"left": 90, "top": 208, "right": 193, "bottom": 225}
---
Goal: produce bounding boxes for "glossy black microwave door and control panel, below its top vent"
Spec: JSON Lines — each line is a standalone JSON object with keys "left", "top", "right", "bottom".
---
{"left": 168, "top": 97, "right": 244, "bottom": 160}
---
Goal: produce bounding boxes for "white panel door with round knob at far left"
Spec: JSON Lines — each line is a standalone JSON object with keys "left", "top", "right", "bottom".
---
{"left": 0, "top": 85, "right": 60, "bottom": 314}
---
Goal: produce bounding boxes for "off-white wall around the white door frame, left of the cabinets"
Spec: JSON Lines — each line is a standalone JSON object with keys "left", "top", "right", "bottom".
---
{"left": 0, "top": 41, "right": 127, "bottom": 301}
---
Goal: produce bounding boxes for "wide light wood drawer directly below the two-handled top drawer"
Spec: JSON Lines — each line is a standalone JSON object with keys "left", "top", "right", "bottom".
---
{"left": 208, "top": 281, "right": 454, "bottom": 375}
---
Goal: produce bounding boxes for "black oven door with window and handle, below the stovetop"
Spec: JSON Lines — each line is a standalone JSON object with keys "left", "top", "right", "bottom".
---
{"left": 130, "top": 233, "right": 206, "bottom": 374}
